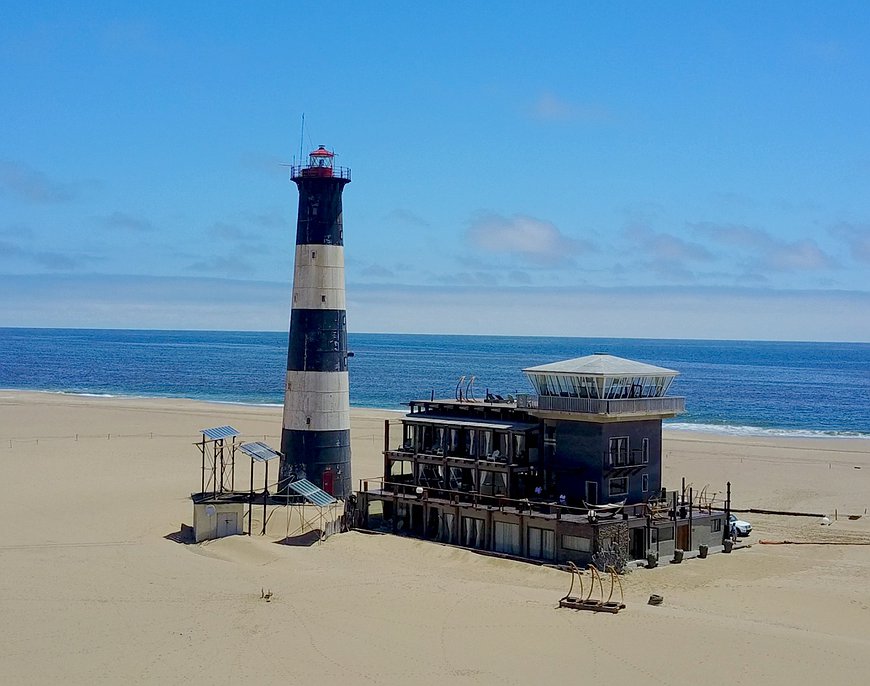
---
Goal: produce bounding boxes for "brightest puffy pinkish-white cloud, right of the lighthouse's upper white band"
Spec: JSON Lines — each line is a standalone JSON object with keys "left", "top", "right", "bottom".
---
{"left": 468, "top": 214, "right": 594, "bottom": 266}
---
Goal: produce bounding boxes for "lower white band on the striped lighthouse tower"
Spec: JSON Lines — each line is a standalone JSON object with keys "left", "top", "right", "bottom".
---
{"left": 283, "top": 371, "right": 350, "bottom": 431}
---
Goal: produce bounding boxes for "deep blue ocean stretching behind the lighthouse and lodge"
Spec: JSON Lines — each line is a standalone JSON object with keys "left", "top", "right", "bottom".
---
{"left": 0, "top": 328, "right": 870, "bottom": 438}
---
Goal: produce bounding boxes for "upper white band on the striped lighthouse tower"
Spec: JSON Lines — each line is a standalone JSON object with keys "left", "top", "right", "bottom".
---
{"left": 293, "top": 244, "right": 346, "bottom": 310}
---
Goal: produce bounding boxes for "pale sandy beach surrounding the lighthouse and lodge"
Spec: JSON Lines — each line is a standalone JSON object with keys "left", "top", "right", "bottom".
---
{"left": 0, "top": 391, "right": 870, "bottom": 686}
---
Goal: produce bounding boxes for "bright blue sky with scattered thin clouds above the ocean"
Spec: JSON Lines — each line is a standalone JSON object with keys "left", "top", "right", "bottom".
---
{"left": 0, "top": 2, "right": 870, "bottom": 341}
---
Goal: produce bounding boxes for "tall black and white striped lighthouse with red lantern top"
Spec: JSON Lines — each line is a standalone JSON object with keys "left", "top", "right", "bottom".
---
{"left": 281, "top": 145, "right": 352, "bottom": 498}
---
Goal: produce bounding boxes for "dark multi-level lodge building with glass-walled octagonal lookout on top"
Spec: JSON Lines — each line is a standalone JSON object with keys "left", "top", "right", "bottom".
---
{"left": 358, "top": 354, "right": 730, "bottom": 564}
